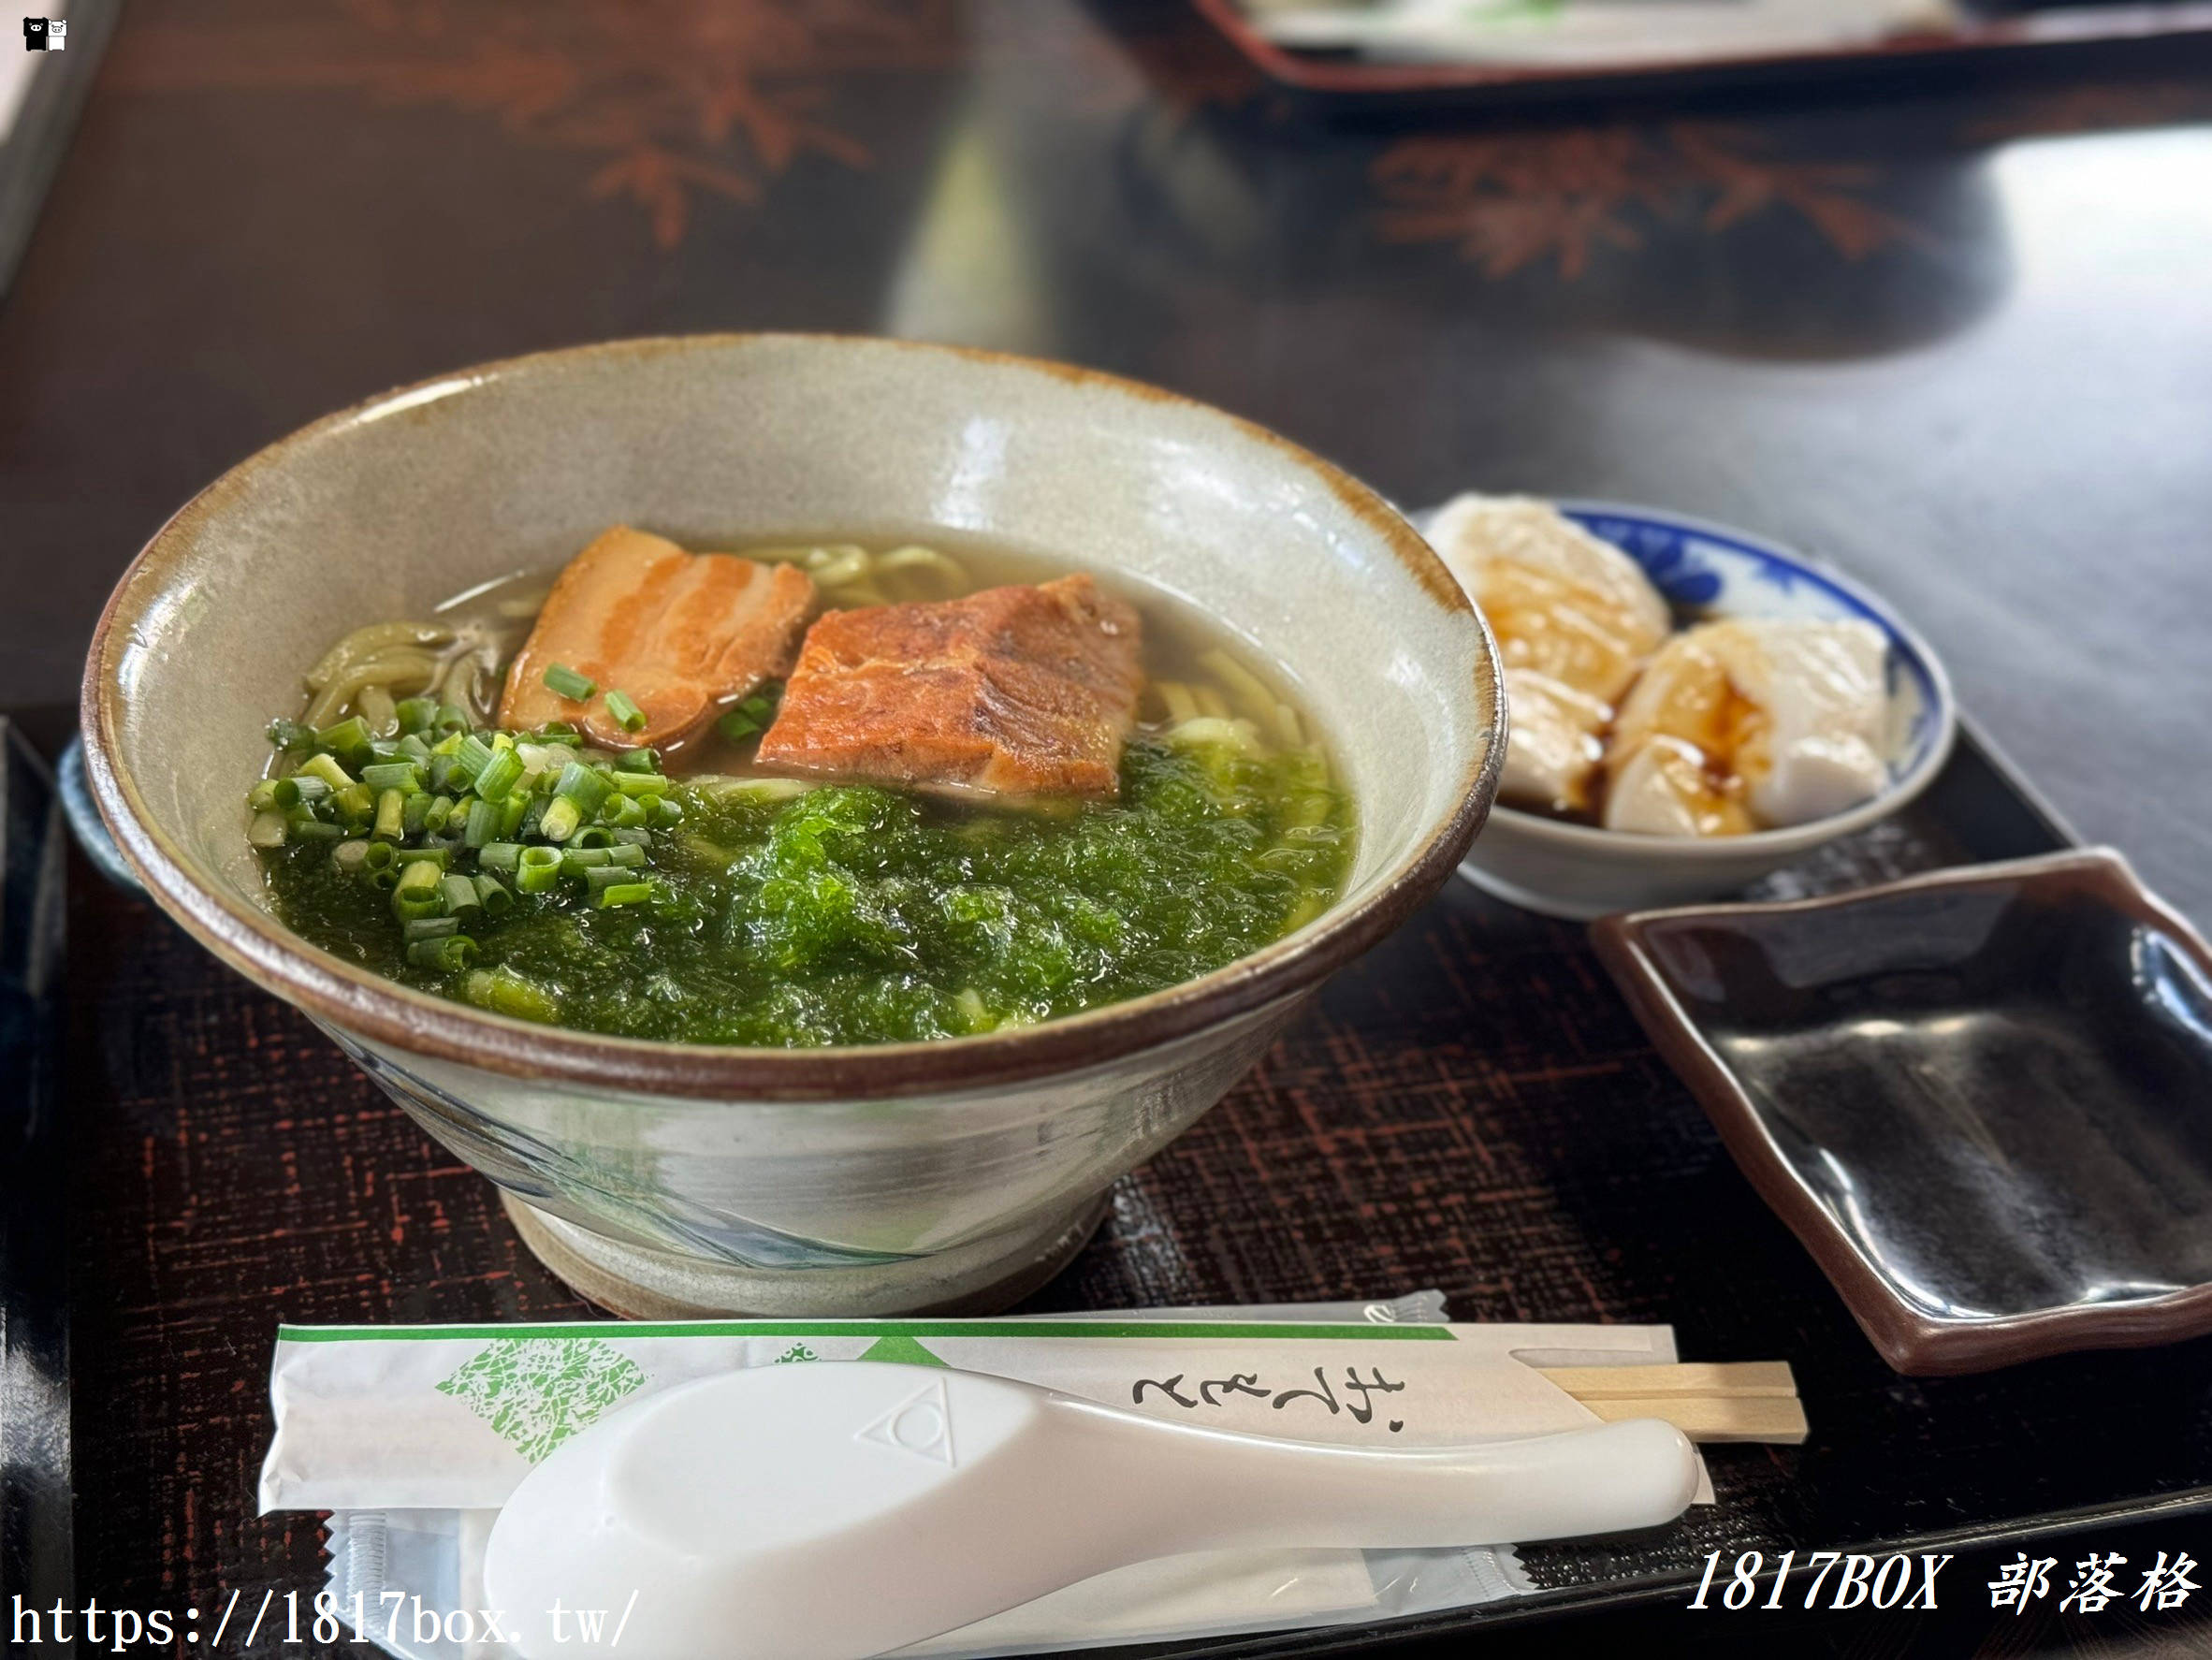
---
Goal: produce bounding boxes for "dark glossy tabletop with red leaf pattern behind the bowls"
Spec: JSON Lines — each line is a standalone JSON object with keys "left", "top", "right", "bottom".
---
{"left": 0, "top": 0, "right": 2212, "bottom": 914}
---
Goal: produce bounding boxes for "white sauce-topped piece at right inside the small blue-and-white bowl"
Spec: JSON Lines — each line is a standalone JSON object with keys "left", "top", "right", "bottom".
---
{"left": 1604, "top": 618, "right": 1889, "bottom": 837}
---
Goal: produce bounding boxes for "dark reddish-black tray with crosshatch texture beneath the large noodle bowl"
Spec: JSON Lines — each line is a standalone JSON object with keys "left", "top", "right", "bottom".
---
{"left": 47, "top": 728, "right": 2212, "bottom": 1660}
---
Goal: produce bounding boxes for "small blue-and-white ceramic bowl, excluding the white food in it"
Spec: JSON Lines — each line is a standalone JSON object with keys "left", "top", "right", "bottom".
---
{"left": 1460, "top": 501, "right": 1957, "bottom": 921}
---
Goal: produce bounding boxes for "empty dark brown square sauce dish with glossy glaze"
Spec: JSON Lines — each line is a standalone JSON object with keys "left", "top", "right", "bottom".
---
{"left": 1593, "top": 848, "right": 2212, "bottom": 1375}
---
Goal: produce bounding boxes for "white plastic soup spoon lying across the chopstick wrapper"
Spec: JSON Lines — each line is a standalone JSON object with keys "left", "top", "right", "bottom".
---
{"left": 485, "top": 1361, "right": 1696, "bottom": 1660}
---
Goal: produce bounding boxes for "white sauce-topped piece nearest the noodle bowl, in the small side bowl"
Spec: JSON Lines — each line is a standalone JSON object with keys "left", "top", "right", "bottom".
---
{"left": 1429, "top": 496, "right": 1670, "bottom": 812}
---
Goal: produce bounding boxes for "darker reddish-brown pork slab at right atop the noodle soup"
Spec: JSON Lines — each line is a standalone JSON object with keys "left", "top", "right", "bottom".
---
{"left": 759, "top": 575, "right": 1143, "bottom": 794}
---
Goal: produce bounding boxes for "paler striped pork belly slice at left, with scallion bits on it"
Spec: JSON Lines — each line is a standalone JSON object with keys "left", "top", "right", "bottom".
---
{"left": 500, "top": 525, "right": 814, "bottom": 748}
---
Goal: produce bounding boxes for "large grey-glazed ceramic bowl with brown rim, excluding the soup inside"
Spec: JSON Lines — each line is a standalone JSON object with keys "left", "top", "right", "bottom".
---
{"left": 84, "top": 337, "right": 1505, "bottom": 1315}
